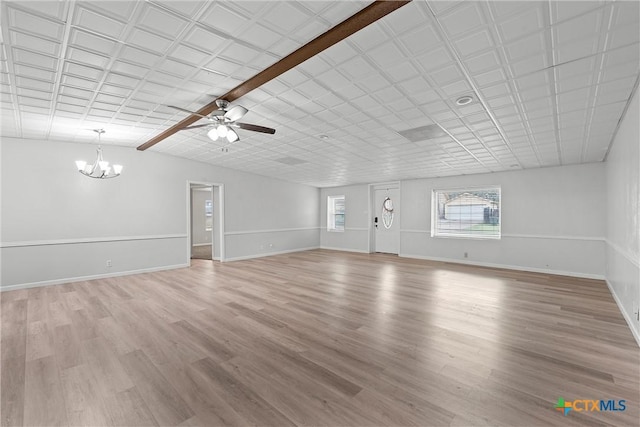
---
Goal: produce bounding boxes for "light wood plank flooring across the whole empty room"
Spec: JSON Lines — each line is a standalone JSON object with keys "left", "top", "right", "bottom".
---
{"left": 1, "top": 250, "right": 640, "bottom": 426}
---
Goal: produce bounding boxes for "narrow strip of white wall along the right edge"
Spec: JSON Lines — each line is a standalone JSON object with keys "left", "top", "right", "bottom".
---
{"left": 605, "top": 90, "right": 640, "bottom": 345}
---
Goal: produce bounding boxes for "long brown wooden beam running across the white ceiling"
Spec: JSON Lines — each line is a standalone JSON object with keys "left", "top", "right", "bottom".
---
{"left": 138, "top": 0, "right": 411, "bottom": 151}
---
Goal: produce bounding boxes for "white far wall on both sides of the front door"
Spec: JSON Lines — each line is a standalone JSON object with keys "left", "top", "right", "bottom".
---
{"left": 320, "top": 164, "right": 606, "bottom": 278}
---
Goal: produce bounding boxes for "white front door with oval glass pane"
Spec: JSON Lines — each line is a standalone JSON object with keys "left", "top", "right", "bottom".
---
{"left": 373, "top": 188, "right": 400, "bottom": 254}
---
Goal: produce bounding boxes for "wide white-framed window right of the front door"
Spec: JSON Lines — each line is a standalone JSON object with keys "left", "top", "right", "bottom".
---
{"left": 431, "top": 187, "right": 500, "bottom": 239}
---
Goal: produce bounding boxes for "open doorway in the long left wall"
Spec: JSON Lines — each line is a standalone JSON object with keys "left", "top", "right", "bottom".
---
{"left": 187, "top": 182, "right": 224, "bottom": 264}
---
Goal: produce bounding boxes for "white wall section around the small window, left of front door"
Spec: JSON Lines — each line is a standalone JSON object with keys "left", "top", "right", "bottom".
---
{"left": 320, "top": 184, "right": 369, "bottom": 252}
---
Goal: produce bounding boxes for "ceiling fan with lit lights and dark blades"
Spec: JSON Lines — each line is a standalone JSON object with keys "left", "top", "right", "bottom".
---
{"left": 168, "top": 99, "right": 276, "bottom": 142}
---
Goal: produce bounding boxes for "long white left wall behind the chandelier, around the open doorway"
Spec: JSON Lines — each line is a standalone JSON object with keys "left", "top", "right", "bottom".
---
{"left": 0, "top": 138, "right": 320, "bottom": 289}
